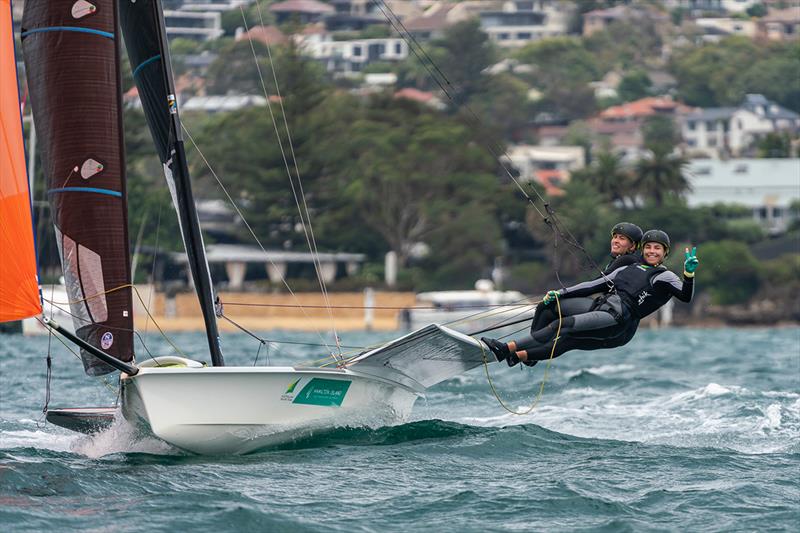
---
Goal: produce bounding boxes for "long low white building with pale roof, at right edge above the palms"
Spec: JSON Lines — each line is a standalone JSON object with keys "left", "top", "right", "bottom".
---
{"left": 685, "top": 158, "right": 800, "bottom": 233}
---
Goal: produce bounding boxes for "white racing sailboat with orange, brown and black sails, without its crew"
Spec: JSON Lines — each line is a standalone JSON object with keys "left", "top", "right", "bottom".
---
{"left": 0, "top": 0, "right": 485, "bottom": 454}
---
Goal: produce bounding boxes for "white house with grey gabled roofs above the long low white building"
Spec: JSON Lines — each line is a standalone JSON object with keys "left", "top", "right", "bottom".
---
{"left": 681, "top": 94, "right": 800, "bottom": 157}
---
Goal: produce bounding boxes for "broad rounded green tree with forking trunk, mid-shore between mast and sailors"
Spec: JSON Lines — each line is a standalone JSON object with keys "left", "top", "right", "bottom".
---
{"left": 342, "top": 97, "right": 499, "bottom": 265}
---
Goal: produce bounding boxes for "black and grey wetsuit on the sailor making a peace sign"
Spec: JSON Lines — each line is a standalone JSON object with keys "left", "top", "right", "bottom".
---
{"left": 517, "top": 264, "right": 694, "bottom": 361}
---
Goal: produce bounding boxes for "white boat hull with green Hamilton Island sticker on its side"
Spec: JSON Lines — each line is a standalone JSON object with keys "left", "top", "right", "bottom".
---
{"left": 122, "top": 367, "right": 422, "bottom": 454}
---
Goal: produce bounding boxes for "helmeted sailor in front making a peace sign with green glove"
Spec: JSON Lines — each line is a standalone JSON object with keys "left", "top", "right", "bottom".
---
{"left": 481, "top": 230, "right": 699, "bottom": 366}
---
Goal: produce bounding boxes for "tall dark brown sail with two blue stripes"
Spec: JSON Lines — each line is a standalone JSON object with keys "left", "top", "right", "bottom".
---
{"left": 21, "top": 0, "right": 133, "bottom": 375}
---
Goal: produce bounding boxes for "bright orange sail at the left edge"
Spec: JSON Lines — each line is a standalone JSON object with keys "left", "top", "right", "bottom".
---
{"left": 0, "top": 0, "right": 42, "bottom": 322}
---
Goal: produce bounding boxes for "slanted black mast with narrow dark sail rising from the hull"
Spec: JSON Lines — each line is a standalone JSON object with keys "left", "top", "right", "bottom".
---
{"left": 118, "top": 0, "right": 225, "bottom": 366}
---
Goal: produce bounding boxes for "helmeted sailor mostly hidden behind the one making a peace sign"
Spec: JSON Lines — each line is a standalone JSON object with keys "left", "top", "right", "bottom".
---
{"left": 529, "top": 222, "right": 642, "bottom": 366}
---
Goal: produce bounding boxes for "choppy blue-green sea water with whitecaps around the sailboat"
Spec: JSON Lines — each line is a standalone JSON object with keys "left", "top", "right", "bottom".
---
{"left": 0, "top": 328, "right": 800, "bottom": 531}
